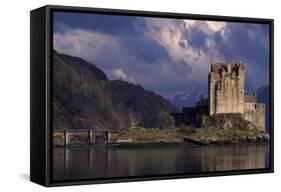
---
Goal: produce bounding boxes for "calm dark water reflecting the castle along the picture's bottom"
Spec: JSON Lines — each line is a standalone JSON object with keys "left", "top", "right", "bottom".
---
{"left": 53, "top": 144, "right": 269, "bottom": 180}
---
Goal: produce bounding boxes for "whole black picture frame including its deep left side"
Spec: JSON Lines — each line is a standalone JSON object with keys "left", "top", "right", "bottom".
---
{"left": 30, "top": 5, "right": 274, "bottom": 186}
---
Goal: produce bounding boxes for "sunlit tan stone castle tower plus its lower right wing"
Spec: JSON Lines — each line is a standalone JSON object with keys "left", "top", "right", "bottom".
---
{"left": 208, "top": 60, "right": 265, "bottom": 130}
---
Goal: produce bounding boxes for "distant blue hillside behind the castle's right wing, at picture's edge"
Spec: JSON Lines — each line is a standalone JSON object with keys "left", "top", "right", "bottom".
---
{"left": 255, "top": 85, "right": 270, "bottom": 131}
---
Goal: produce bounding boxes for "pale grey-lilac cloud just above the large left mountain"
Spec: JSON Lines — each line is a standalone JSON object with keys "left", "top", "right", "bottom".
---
{"left": 54, "top": 28, "right": 127, "bottom": 70}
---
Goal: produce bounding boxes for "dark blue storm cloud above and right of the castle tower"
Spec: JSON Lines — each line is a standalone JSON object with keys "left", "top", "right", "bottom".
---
{"left": 179, "top": 23, "right": 269, "bottom": 92}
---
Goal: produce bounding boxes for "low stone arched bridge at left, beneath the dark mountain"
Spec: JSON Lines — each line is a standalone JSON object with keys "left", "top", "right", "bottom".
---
{"left": 53, "top": 129, "right": 119, "bottom": 146}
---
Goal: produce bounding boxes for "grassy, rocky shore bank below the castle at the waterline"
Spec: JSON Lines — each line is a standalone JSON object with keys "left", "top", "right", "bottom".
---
{"left": 117, "top": 123, "right": 269, "bottom": 144}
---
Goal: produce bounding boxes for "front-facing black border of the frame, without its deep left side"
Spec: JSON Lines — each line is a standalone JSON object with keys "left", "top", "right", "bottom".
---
{"left": 40, "top": 5, "right": 274, "bottom": 187}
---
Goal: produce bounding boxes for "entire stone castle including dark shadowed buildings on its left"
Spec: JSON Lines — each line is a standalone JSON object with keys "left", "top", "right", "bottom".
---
{"left": 171, "top": 61, "right": 265, "bottom": 130}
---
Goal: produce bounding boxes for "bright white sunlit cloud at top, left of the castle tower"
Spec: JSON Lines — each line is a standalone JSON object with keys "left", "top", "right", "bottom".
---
{"left": 145, "top": 18, "right": 225, "bottom": 85}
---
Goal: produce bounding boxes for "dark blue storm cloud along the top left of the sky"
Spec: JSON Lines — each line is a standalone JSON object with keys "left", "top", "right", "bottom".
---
{"left": 54, "top": 12, "right": 169, "bottom": 68}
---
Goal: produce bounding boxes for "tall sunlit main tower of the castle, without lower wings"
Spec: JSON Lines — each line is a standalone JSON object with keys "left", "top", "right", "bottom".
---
{"left": 209, "top": 61, "right": 245, "bottom": 115}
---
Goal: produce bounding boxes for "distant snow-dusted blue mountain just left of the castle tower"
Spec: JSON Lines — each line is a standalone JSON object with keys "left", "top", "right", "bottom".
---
{"left": 172, "top": 91, "right": 207, "bottom": 108}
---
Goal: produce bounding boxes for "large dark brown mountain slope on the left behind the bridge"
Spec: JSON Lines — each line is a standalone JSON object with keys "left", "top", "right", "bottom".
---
{"left": 53, "top": 51, "right": 177, "bottom": 130}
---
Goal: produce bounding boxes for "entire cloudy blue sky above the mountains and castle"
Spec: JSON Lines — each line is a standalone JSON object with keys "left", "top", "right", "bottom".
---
{"left": 53, "top": 12, "right": 270, "bottom": 99}
